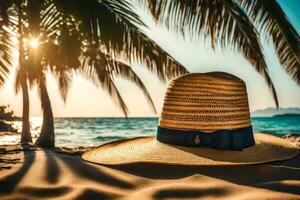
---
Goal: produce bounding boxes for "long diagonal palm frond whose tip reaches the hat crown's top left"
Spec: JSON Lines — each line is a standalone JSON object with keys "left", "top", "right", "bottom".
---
{"left": 54, "top": 0, "right": 188, "bottom": 80}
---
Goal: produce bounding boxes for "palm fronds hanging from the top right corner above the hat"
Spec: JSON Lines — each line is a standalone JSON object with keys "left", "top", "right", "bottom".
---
{"left": 139, "top": 0, "right": 300, "bottom": 107}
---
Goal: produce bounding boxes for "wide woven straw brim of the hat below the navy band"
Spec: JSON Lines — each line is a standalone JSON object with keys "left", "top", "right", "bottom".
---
{"left": 82, "top": 133, "right": 299, "bottom": 166}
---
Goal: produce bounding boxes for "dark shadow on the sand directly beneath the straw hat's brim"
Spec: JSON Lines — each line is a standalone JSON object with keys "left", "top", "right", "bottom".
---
{"left": 112, "top": 156, "right": 300, "bottom": 197}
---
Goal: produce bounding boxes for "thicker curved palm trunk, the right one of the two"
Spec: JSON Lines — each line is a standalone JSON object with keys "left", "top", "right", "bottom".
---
{"left": 35, "top": 80, "right": 55, "bottom": 148}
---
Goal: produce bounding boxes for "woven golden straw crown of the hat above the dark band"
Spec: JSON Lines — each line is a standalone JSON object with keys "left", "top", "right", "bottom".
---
{"left": 159, "top": 72, "right": 251, "bottom": 133}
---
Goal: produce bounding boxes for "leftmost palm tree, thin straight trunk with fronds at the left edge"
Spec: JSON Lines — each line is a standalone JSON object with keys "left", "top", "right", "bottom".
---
{"left": 0, "top": 0, "right": 32, "bottom": 143}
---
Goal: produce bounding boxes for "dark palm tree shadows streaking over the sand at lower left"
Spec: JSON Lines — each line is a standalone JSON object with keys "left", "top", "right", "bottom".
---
{"left": 0, "top": 149, "right": 135, "bottom": 200}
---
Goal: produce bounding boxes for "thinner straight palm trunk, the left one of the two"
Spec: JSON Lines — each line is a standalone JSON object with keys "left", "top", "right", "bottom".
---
{"left": 21, "top": 79, "right": 32, "bottom": 143}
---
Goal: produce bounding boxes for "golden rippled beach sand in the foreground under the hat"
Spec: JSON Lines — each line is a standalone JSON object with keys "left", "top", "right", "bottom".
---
{"left": 0, "top": 138, "right": 300, "bottom": 200}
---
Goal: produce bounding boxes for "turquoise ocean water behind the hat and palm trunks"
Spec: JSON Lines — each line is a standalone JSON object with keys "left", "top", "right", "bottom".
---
{"left": 0, "top": 116, "right": 300, "bottom": 147}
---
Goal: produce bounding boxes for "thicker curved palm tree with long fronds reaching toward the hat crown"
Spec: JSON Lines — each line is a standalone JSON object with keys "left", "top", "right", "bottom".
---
{"left": 37, "top": 0, "right": 188, "bottom": 147}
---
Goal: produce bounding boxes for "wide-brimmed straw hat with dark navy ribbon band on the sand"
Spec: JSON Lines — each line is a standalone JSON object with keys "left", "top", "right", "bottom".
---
{"left": 82, "top": 72, "right": 299, "bottom": 165}
